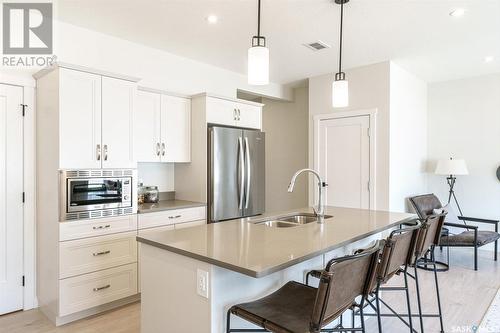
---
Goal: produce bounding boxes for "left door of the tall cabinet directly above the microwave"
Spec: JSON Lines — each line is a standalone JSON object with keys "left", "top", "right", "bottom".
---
{"left": 58, "top": 68, "right": 102, "bottom": 169}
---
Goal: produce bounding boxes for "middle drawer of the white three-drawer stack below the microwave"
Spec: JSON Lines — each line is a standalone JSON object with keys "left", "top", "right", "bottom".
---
{"left": 59, "top": 231, "right": 137, "bottom": 279}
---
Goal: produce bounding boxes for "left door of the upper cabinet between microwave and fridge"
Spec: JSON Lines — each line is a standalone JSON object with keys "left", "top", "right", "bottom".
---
{"left": 133, "top": 91, "right": 161, "bottom": 162}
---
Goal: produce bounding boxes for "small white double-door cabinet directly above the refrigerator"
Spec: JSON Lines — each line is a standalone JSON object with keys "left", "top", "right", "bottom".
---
{"left": 206, "top": 96, "right": 262, "bottom": 129}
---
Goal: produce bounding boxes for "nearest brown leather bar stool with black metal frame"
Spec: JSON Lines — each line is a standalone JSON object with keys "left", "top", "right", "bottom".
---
{"left": 226, "top": 242, "right": 383, "bottom": 333}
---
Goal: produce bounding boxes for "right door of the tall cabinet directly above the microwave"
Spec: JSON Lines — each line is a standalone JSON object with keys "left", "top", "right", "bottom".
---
{"left": 102, "top": 76, "right": 137, "bottom": 168}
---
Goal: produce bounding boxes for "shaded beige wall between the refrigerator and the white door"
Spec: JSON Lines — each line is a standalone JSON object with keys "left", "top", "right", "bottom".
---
{"left": 262, "top": 87, "right": 308, "bottom": 212}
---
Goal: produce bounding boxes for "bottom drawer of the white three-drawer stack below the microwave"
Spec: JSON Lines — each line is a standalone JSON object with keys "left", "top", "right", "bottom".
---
{"left": 59, "top": 263, "right": 137, "bottom": 316}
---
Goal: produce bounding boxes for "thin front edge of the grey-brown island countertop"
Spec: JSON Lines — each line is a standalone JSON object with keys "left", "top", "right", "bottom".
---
{"left": 136, "top": 216, "right": 416, "bottom": 278}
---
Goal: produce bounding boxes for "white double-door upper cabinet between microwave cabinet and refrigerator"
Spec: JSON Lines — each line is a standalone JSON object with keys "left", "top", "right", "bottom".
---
{"left": 134, "top": 90, "right": 191, "bottom": 162}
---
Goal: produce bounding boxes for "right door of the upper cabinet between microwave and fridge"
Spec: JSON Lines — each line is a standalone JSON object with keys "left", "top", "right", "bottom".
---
{"left": 161, "top": 95, "right": 191, "bottom": 162}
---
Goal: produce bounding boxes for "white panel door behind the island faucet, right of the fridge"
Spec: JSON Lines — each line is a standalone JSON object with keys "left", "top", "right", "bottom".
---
{"left": 316, "top": 116, "right": 370, "bottom": 209}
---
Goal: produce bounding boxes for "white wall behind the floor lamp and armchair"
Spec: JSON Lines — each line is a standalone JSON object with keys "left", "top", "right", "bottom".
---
{"left": 428, "top": 74, "right": 500, "bottom": 223}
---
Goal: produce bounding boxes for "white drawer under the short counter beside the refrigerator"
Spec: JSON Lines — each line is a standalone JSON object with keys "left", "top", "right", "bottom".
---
{"left": 138, "top": 207, "right": 206, "bottom": 229}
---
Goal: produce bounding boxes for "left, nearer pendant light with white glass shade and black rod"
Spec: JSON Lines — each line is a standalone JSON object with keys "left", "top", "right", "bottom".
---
{"left": 248, "top": 0, "right": 269, "bottom": 85}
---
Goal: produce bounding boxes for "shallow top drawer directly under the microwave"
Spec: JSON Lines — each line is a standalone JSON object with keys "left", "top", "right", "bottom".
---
{"left": 59, "top": 214, "right": 137, "bottom": 241}
